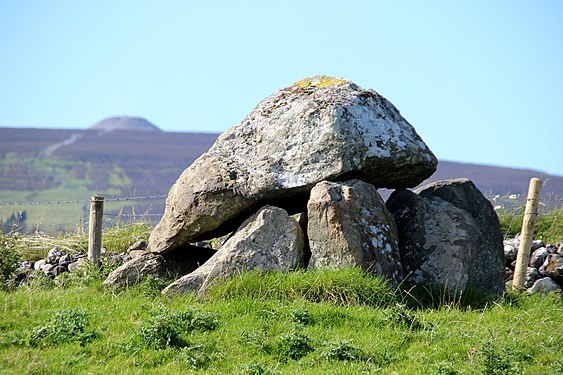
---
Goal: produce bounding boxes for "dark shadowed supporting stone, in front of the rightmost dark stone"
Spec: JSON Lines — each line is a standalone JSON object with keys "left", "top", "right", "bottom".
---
{"left": 387, "top": 189, "right": 480, "bottom": 295}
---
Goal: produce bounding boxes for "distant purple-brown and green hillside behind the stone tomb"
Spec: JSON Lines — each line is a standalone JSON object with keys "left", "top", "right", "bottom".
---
{"left": 0, "top": 127, "right": 563, "bottom": 232}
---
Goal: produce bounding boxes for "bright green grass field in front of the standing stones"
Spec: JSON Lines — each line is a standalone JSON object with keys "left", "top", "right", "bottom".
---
{"left": 0, "top": 269, "right": 563, "bottom": 374}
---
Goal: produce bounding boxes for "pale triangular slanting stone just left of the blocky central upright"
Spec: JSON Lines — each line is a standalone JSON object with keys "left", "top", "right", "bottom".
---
{"left": 163, "top": 206, "right": 303, "bottom": 294}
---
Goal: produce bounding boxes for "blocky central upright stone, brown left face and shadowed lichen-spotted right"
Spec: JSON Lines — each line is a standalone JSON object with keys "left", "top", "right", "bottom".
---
{"left": 307, "top": 180, "right": 403, "bottom": 285}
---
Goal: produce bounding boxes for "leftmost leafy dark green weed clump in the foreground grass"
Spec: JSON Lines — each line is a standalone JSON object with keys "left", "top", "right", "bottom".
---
{"left": 30, "top": 309, "right": 97, "bottom": 346}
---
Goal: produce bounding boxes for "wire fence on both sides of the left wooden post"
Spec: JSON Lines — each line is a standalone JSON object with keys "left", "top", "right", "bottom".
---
{"left": 0, "top": 194, "right": 167, "bottom": 235}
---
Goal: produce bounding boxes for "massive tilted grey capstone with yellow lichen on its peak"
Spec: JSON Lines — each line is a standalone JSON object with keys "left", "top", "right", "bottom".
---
{"left": 149, "top": 77, "right": 437, "bottom": 253}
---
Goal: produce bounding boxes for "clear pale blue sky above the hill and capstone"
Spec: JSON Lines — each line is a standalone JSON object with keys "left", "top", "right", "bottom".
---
{"left": 0, "top": 0, "right": 563, "bottom": 175}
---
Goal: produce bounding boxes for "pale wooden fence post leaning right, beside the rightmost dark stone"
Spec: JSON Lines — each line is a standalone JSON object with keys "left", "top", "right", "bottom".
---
{"left": 512, "top": 177, "right": 541, "bottom": 290}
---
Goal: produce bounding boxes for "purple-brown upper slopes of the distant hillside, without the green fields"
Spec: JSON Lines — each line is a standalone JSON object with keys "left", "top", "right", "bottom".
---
{"left": 0, "top": 128, "right": 563, "bottom": 199}
